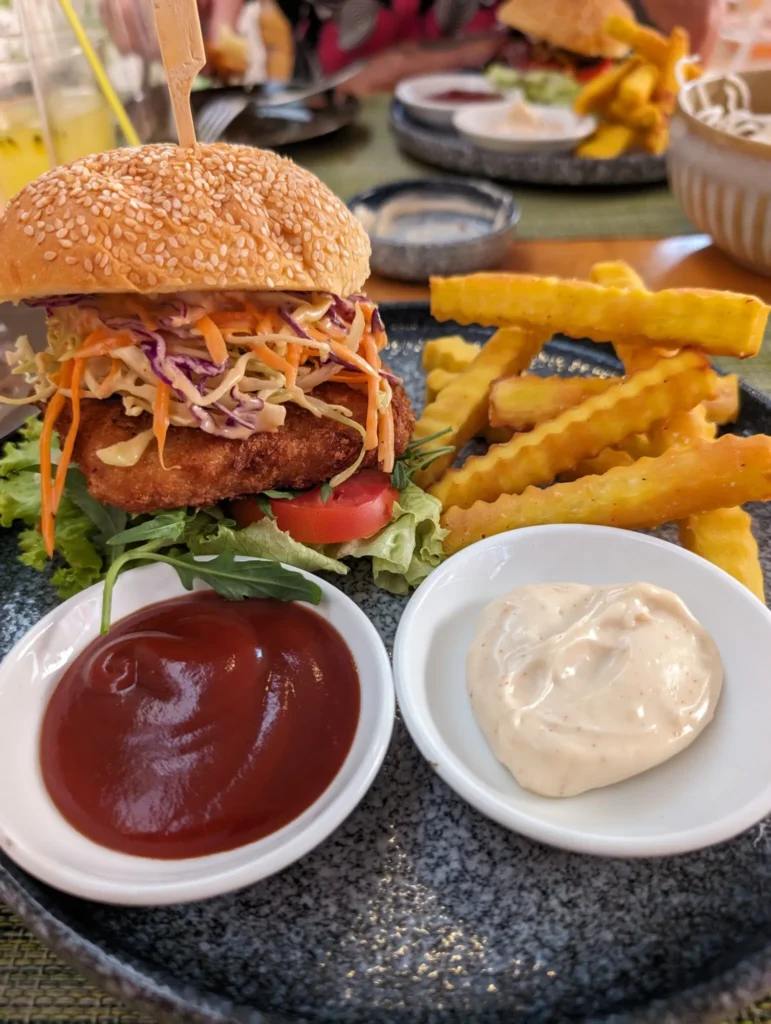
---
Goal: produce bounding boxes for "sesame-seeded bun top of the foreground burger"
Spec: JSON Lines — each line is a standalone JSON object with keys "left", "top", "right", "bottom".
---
{"left": 0, "top": 143, "right": 370, "bottom": 301}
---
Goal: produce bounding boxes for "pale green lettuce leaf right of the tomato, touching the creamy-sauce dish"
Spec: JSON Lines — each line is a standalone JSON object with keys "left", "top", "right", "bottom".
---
{"left": 325, "top": 482, "right": 447, "bottom": 594}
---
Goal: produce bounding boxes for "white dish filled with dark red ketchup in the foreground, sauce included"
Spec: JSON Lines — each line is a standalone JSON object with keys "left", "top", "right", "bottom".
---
{"left": 0, "top": 564, "right": 394, "bottom": 905}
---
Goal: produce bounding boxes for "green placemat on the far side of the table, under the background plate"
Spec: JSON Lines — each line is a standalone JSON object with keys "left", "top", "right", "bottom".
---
{"left": 286, "top": 95, "right": 695, "bottom": 239}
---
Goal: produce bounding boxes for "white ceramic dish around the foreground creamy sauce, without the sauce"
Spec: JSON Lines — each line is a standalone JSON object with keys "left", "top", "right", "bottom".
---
{"left": 394, "top": 525, "right": 771, "bottom": 857}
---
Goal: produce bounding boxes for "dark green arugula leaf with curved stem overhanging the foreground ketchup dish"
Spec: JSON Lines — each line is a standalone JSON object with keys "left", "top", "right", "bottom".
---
{"left": 101, "top": 545, "right": 322, "bottom": 633}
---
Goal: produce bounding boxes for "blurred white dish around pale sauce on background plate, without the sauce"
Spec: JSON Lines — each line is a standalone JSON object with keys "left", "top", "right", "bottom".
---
{"left": 453, "top": 99, "right": 597, "bottom": 153}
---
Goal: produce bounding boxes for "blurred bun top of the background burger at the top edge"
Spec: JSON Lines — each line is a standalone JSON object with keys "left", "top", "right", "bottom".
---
{"left": 498, "top": 0, "right": 635, "bottom": 58}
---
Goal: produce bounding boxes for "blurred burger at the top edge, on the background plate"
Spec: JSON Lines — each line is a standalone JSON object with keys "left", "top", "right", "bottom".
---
{"left": 498, "top": 0, "right": 635, "bottom": 82}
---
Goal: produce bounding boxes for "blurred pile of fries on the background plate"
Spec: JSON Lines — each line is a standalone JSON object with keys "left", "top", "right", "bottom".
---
{"left": 573, "top": 14, "right": 701, "bottom": 160}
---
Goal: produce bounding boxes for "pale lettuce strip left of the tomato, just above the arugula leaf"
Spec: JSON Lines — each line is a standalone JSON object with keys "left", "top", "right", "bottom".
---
{"left": 187, "top": 518, "right": 349, "bottom": 575}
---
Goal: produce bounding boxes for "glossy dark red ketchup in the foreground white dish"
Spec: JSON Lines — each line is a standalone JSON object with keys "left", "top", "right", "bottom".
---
{"left": 40, "top": 592, "right": 360, "bottom": 858}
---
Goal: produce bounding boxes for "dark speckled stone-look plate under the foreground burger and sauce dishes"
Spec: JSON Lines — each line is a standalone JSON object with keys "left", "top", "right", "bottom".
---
{"left": 0, "top": 305, "right": 771, "bottom": 1024}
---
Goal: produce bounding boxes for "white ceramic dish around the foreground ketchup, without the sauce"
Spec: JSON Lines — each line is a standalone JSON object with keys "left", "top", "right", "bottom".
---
{"left": 0, "top": 564, "right": 394, "bottom": 905}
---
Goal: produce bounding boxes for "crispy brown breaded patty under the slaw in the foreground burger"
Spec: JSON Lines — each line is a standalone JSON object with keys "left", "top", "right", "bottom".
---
{"left": 56, "top": 382, "right": 415, "bottom": 513}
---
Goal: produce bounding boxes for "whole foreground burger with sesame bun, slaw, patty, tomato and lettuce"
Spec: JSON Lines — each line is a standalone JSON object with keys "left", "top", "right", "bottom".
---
{"left": 0, "top": 144, "right": 442, "bottom": 593}
